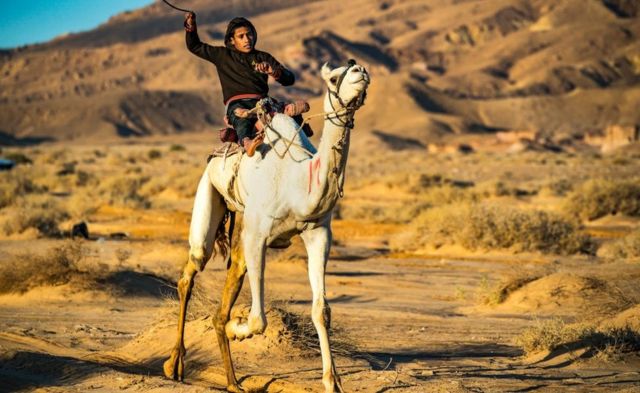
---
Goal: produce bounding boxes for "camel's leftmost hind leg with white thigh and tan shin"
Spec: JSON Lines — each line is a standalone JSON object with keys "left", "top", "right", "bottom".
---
{"left": 163, "top": 165, "right": 226, "bottom": 381}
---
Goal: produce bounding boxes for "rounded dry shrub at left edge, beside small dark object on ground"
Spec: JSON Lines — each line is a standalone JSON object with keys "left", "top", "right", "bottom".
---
{"left": 4, "top": 195, "right": 69, "bottom": 237}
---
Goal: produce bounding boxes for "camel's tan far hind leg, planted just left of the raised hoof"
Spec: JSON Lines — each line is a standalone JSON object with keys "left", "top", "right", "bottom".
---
{"left": 215, "top": 234, "right": 247, "bottom": 392}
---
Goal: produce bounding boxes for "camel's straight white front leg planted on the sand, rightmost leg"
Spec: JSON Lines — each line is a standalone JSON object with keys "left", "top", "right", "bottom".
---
{"left": 300, "top": 223, "right": 343, "bottom": 393}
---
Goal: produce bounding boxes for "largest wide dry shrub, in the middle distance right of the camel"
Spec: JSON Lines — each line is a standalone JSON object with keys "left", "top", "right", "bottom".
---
{"left": 413, "top": 204, "right": 593, "bottom": 254}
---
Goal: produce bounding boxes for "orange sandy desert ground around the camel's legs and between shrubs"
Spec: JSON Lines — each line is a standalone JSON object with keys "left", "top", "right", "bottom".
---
{"left": 0, "top": 138, "right": 640, "bottom": 392}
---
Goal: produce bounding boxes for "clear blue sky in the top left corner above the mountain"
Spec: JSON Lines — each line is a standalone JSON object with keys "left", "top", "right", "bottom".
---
{"left": 0, "top": 0, "right": 153, "bottom": 48}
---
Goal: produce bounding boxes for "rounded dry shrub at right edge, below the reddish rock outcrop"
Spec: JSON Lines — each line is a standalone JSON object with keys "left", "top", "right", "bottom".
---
{"left": 565, "top": 179, "right": 640, "bottom": 220}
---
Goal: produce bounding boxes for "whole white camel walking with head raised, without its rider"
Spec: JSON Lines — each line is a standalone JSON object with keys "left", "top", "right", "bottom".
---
{"left": 164, "top": 60, "right": 369, "bottom": 392}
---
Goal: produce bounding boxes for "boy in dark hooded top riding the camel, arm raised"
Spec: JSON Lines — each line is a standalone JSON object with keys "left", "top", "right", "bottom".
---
{"left": 184, "top": 12, "right": 302, "bottom": 157}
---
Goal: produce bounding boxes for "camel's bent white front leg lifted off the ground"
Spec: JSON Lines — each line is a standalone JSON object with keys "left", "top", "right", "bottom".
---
{"left": 225, "top": 225, "right": 268, "bottom": 340}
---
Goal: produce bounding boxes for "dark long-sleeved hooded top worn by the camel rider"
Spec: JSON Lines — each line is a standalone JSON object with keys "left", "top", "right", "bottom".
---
{"left": 186, "top": 27, "right": 295, "bottom": 103}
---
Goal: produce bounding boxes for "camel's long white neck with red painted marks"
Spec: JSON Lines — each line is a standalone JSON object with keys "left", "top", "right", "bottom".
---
{"left": 308, "top": 94, "right": 351, "bottom": 214}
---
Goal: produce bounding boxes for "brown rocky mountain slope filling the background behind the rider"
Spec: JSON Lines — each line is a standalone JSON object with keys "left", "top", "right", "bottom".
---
{"left": 0, "top": 0, "right": 640, "bottom": 144}
